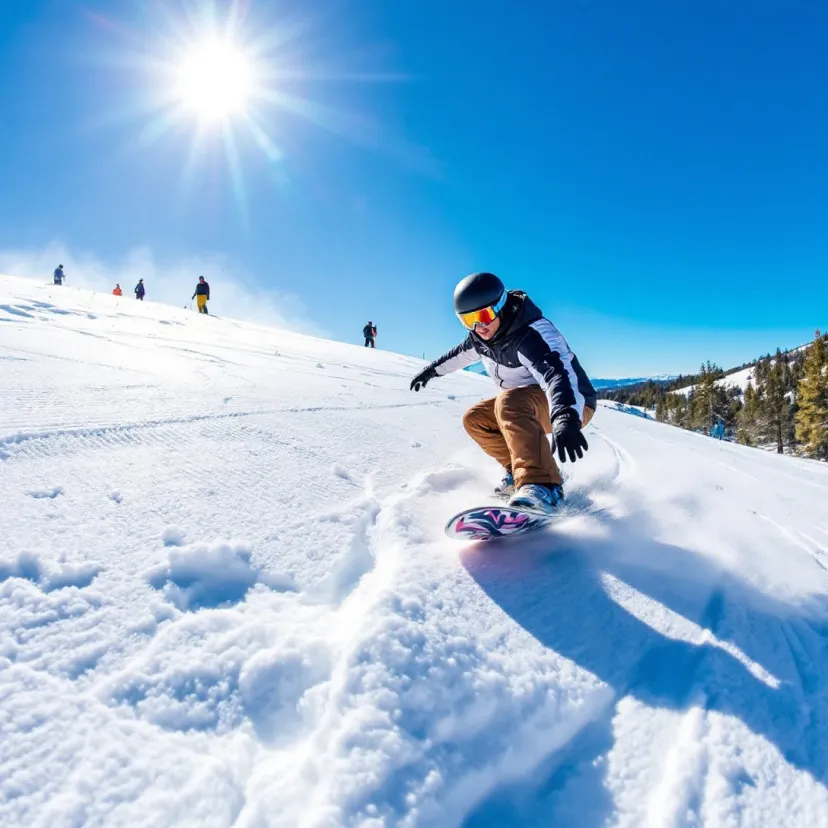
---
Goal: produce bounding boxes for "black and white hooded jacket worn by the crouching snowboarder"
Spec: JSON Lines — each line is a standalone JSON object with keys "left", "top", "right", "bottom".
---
{"left": 431, "top": 290, "right": 596, "bottom": 420}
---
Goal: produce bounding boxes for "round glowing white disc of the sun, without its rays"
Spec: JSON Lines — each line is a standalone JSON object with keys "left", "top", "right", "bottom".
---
{"left": 176, "top": 38, "right": 254, "bottom": 121}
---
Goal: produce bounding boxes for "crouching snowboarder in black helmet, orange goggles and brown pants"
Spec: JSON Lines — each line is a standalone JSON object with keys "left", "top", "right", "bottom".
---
{"left": 411, "top": 273, "right": 597, "bottom": 513}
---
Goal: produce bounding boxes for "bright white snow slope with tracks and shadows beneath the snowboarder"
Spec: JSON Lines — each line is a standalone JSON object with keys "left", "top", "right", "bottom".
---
{"left": 0, "top": 278, "right": 828, "bottom": 828}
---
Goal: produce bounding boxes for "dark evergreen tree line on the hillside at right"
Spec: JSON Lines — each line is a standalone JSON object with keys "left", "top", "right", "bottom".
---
{"left": 602, "top": 331, "right": 828, "bottom": 460}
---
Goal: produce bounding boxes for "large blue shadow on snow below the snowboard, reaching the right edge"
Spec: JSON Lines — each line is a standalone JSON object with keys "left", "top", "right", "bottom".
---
{"left": 462, "top": 494, "right": 828, "bottom": 828}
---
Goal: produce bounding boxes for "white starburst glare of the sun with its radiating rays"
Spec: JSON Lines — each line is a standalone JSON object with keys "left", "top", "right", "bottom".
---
{"left": 122, "top": 0, "right": 408, "bottom": 225}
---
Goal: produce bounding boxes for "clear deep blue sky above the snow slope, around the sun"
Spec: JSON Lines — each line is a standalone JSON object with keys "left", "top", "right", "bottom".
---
{"left": 0, "top": 0, "right": 828, "bottom": 376}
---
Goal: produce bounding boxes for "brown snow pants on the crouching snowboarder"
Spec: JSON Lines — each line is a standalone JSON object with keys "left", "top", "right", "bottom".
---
{"left": 463, "top": 385, "right": 595, "bottom": 488}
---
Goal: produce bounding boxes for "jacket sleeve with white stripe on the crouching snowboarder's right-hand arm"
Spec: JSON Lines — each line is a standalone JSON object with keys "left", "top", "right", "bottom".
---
{"left": 518, "top": 319, "right": 584, "bottom": 420}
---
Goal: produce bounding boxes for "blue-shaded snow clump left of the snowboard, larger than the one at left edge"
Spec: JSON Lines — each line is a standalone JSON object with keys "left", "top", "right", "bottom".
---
{"left": 146, "top": 532, "right": 296, "bottom": 611}
